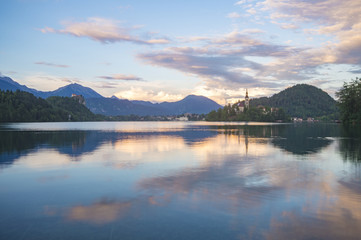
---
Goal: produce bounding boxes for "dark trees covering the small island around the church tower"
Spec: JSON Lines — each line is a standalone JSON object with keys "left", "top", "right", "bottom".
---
{"left": 205, "top": 102, "right": 290, "bottom": 122}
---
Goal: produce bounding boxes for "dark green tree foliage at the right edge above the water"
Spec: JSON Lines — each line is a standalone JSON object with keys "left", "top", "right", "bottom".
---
{"left": 336, "top": 78, "right": 361, "bottom": 123}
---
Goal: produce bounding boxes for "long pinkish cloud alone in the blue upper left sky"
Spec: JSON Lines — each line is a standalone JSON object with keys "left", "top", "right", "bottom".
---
{"left": 40, "top": 17, "right": 170, "bottom": 45}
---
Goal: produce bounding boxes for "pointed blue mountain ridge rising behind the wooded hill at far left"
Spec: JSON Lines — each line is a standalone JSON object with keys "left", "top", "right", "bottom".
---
{"left": 0, "top": 77, "right": 103, "bottom": 98}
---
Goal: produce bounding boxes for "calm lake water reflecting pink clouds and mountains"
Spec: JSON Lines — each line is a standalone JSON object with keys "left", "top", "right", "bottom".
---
{"left": 0, "top": 122, "right": 361, "bottom": 240}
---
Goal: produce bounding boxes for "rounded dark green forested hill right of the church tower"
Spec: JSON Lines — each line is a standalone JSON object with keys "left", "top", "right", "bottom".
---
{"left": 250, "top": 84, "right": 338, "bottom": 118}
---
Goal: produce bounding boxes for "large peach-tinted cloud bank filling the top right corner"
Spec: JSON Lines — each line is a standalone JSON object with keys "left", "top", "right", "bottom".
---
{"left": 264, "top": 0, "right": 361, "bottom": 65}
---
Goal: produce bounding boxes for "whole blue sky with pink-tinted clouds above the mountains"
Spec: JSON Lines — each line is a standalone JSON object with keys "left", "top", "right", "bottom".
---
{"left": 0, "top": 0, "right": 361, "bottom": 104}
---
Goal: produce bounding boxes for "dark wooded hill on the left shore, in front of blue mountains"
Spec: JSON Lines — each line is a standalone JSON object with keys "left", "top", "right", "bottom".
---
{"left": 0, "top": 90, "right": 104, "bottom": 122}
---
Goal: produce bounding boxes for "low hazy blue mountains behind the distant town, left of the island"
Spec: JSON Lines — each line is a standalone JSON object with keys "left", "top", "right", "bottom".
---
{"left": 86, "top": 95, "right": 222, "bottom": 116}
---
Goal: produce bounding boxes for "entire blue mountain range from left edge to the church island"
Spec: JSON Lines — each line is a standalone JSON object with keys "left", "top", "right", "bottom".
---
{"left": 0, "top": 77, "right": 222, "bottom": 116}
